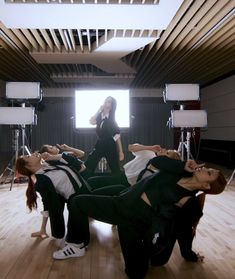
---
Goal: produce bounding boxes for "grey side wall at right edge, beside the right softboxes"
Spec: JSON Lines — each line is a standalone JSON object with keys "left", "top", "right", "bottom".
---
{"left": 201, "top": 75, "right": 235, "bottom": 141}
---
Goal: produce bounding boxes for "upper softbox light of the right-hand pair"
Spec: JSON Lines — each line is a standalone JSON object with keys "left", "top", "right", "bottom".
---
{"left": 163, "top": 83, "right": 200, "bottom": 101}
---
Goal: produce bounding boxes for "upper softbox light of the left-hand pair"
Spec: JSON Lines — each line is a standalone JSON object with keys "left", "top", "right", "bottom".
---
{"left": 6, "top": 82, "right": 40, "bottom": 100}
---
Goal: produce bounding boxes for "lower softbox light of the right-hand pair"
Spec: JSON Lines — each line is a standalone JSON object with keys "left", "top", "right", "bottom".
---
{"left": 171, "top": 110, "right": 207, "bottom": 128}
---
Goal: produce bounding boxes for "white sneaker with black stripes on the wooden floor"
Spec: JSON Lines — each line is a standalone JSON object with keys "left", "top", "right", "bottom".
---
{"left": 53, "top": 243, "right": 86, "bottom": 260}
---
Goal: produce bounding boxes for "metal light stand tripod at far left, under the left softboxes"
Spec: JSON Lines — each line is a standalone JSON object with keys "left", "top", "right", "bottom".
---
{"left": 0, "top": 125, "right": 31, "bottom": 190}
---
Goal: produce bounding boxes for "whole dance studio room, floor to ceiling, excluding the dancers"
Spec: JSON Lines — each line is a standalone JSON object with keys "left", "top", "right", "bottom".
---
{"left": 0, "top": 0, "right": 235, "bottom": 279}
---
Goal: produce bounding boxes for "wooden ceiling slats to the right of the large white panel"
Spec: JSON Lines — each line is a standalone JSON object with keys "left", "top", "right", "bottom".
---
{"left": 130, "top": 1, "right": 235, "bottom": 87}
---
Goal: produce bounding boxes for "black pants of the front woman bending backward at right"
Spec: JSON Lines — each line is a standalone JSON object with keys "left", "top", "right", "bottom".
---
{"left": 67, "top": 195, "right": 153, "bottom": 279}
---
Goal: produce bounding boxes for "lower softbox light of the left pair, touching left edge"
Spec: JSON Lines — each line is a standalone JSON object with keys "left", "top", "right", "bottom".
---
{"left": 0, "top": 107, "right": 34, "bottom": 125}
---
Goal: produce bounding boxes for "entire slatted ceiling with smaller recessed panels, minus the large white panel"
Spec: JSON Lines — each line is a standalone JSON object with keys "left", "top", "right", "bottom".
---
{"left": 0, "top": 0, "right": 235, "bottom": 88}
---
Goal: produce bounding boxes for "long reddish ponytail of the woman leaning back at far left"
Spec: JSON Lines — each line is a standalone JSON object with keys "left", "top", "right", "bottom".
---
{"left": 15, "top": 157, "right": 38, "bottom": 211}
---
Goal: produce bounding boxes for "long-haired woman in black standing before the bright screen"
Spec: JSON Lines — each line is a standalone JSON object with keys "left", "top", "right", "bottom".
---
{"left": 85, "top": 96, "right": 124, "bottom": 174}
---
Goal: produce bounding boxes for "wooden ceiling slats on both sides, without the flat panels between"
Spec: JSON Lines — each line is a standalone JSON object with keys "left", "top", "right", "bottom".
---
{"left": 0, "top": 0, "right": 235, "bottom": 88}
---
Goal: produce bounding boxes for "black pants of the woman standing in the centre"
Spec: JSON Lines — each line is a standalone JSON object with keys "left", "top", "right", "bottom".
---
{"left": 85, "top": 138, "right": 120, "bottom": 174}
